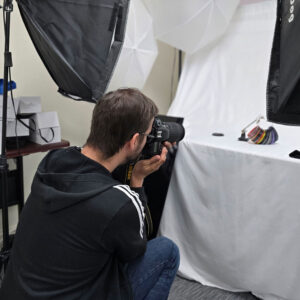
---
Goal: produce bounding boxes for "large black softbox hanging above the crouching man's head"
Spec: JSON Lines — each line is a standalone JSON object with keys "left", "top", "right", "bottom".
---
{"left": 18, "top": 0, "right": 129, "bottom": 102}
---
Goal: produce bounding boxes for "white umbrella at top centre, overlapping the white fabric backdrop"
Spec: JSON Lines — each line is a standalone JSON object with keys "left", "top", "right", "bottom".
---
{"left": 144, "top": 0, "right": 240, "bottom": 53}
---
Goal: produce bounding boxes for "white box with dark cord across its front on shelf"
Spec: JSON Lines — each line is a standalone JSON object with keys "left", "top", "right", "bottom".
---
{"left": 29, "top": 111, "right": 61, "bottom": 145}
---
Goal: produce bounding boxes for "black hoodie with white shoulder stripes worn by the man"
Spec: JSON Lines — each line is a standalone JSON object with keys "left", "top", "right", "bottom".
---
{"left": 0, "top": 147, "right": 147, "bottom": 300}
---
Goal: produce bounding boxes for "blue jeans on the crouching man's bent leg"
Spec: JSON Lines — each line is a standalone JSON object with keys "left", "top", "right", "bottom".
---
{"left": 127, "top": 237, "right": 179, "bottom": 300}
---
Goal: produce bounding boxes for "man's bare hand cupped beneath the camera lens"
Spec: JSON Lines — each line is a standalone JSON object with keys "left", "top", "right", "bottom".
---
{"left": 130, "top": 146, "right": 172, "bottom": 187}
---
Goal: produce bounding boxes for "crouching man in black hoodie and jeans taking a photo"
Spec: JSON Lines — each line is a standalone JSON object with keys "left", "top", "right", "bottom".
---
{"left": 0, "top": 89, "right": 179, "bottom": 300}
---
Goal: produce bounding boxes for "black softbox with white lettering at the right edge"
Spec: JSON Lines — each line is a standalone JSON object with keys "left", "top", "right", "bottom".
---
{"left": 267, "top": 0, "right": 300, "bottom": 125}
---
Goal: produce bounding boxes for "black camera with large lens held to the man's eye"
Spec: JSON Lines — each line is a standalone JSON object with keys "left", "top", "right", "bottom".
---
{"left": 142, "top": 117, "right": 185, "bottom": 159}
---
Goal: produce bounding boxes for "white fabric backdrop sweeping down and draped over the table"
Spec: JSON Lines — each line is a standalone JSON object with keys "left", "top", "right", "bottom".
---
{"left": 160, "top": 0, "right": 300, "bottom": 300}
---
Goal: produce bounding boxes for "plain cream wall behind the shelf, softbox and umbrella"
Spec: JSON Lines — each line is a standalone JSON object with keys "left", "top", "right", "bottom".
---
{"left": 0, "top": 2, "right": 177, "bottom": 237}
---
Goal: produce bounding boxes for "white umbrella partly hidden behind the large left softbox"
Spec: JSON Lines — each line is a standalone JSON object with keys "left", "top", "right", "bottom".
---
{"left": 108, "top": 0, "right": 157, "bottom": 90}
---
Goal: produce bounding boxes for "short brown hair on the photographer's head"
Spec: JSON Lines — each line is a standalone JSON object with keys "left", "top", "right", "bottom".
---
{"left": 87, "top": 88, "right": 158, "bottom": 158}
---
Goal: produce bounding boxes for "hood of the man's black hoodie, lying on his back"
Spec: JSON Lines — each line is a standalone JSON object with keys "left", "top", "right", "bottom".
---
{"left": 31, "top": 147, "right": 119, "bottom": 213}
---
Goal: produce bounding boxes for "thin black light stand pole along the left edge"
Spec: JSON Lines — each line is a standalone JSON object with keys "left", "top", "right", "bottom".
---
{"left": 0, "top": 0, "right": 13, "bottom": 268}
